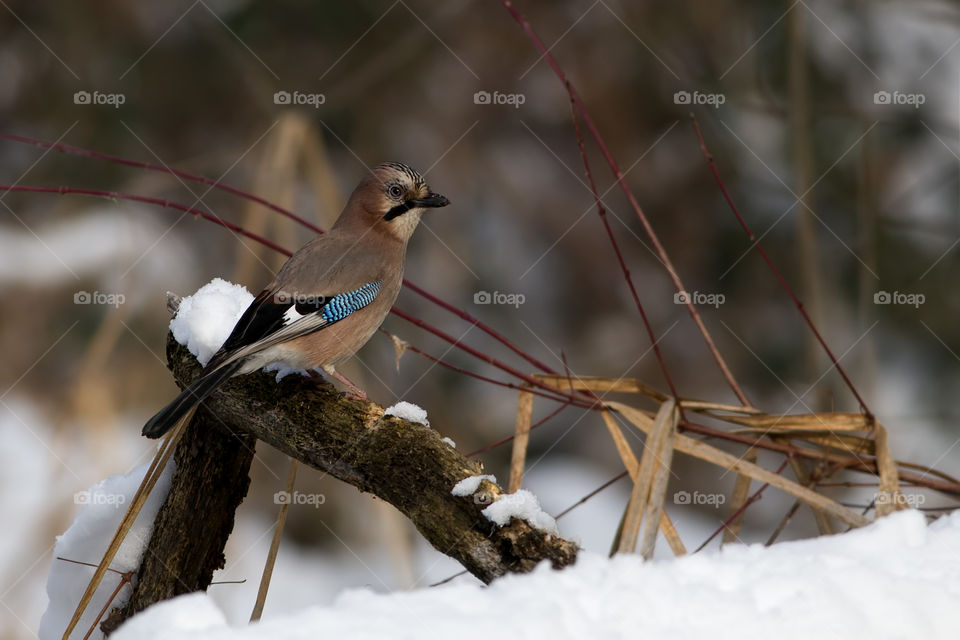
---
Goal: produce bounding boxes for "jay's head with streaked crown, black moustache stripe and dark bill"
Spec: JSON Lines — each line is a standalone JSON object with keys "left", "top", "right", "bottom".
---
{"left": 336, "top": 162, "right": 450, "bottom": 242}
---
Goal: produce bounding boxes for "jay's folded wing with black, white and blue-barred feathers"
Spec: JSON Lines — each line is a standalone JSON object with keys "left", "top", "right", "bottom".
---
{"left": 206, "top": 280, "right": 381, "bottom": 371}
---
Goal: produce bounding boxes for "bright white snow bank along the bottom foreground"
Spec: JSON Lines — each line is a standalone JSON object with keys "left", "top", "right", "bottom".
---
{"left": 113, "top": 511, "right": 960, "bottom": 640}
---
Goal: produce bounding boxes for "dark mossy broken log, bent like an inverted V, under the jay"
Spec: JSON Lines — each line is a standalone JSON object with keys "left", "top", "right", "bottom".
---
{"left": 104, "top": 336, "right": 577, "bottom": 631}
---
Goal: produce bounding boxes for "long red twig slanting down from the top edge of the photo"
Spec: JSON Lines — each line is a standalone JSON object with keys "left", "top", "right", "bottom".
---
{"left": 500, "top": 0, "right": 750, "bottom": 406}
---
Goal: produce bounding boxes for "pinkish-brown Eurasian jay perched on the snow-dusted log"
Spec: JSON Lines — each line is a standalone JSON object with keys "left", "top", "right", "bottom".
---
{"left": 143, "top": 162, "right": 450, "bottom": 438}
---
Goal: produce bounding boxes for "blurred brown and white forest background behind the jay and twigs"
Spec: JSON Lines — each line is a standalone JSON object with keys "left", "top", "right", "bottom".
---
{"left": 0, "top": 0, "right": 960, "bottom": 638}
